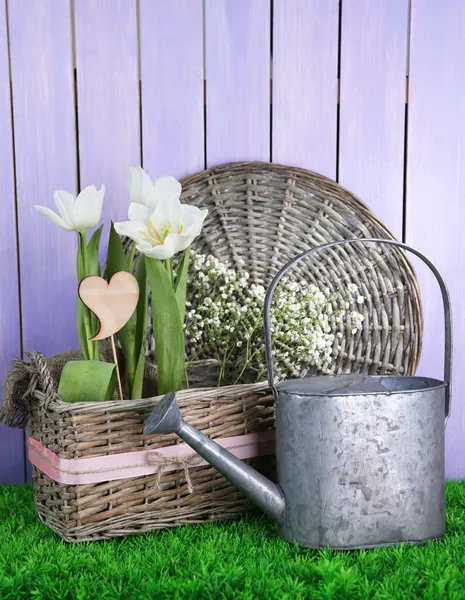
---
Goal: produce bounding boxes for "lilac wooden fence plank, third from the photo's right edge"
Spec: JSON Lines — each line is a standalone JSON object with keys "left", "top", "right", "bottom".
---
{"left": 272, "top": 0, "right": 339, "bottom": 179}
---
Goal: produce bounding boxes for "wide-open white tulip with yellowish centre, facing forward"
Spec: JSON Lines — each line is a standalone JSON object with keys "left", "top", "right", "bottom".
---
{"left": 115, "top": 196, "right": 208, "bottom": 260}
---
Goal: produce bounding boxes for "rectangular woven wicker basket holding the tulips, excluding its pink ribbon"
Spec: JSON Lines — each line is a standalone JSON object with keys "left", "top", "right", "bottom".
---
{"left": 26, "top": 356, "right": 274, "bottom": 542}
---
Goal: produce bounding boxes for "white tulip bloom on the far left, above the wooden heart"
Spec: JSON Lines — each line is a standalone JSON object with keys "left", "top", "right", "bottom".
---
{"left": 34, "top": 185, "right": 105, "bottom": 232}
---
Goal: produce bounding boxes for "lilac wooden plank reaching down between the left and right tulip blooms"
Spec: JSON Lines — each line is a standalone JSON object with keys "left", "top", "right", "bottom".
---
{"left": 74, "top": 0, "right": 140, "bottom": 230}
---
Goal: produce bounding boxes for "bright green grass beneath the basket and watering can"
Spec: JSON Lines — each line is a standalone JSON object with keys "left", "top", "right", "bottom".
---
{"left": 0, "top": 481, "right": 465, "bottom": 600}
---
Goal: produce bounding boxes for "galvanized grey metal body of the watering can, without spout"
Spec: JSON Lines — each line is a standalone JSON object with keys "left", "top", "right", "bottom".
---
{"left": 276, "top": 378, "right": 445, "bottom": 549}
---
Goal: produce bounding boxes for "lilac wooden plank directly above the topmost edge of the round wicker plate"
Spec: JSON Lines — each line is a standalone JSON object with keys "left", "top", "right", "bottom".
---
{"left": 205, "top": 0, "right": 271, "bottom": 166}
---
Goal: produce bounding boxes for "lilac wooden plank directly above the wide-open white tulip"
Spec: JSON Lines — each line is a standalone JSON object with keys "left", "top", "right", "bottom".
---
{"left": 140, "top": 0, "right": 204, "bottom": 178}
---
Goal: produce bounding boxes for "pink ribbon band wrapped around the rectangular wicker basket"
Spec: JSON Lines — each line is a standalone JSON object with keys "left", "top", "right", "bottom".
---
{"left": 28, "top": 430, "right": 275, "bottom": 485}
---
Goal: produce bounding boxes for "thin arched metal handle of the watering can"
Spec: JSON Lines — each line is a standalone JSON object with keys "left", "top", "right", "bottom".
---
{"left": 263, "top": 238, "right": 452, "bottom": 421}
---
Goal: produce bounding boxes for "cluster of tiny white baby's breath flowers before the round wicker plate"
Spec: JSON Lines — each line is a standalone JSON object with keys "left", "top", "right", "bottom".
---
{"left": 186, "top": 254, "right": 363, "bottom": 383}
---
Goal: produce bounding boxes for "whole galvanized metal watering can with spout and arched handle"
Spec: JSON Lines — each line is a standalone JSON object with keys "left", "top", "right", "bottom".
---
{"left": 144, "top": 239, "right": 452, "bottom": 550}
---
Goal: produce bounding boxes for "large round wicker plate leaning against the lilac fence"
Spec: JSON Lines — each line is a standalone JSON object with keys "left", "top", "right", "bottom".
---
{"left": 141, "top": 162, "right": 423, "bottom": 375}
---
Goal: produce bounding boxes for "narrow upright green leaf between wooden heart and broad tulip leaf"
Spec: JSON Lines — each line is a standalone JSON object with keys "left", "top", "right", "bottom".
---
{"left": 130, "top": 255, "right": 148, "bottom": 399}
